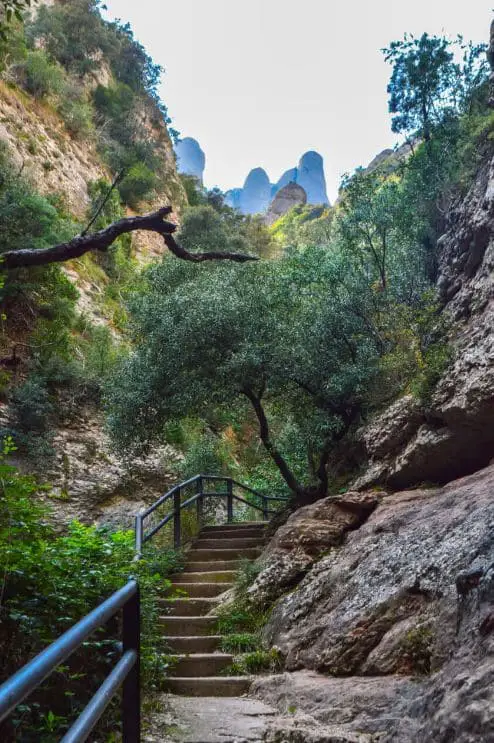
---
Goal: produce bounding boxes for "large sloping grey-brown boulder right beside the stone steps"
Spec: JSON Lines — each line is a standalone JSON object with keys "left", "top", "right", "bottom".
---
{"left": 253, "top": 466, "right": 494, "bottom": 743}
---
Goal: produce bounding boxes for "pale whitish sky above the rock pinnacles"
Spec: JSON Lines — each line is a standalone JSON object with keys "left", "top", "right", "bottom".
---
{"left": 102, "top": 0, "right": 494, "bottom": 200}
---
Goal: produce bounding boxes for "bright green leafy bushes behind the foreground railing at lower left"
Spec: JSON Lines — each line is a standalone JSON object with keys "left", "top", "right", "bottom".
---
{"left": 0, "top": 440, "right": 180, "bottom": 741}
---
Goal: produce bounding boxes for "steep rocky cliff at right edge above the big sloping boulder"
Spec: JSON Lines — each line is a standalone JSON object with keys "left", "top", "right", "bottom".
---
{"left": 354, "top": 149, "right": 494, "bottom": 488}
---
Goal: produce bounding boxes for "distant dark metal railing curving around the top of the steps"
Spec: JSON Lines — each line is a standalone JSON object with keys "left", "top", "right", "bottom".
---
{"left": 135, "top": 474, "right": 287, "bottom": 556}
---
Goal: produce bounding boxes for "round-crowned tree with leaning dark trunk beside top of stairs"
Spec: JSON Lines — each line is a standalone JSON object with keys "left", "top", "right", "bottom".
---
{"left": 107, "top": 249, "right": 378, "bottom": 502}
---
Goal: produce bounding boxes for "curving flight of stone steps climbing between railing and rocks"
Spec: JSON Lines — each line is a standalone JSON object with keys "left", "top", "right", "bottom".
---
{"left": 160, "top": 522, "right": 266, "bottom": 697}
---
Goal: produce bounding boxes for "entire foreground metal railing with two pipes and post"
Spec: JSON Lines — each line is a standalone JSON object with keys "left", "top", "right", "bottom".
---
{"left": 0, "top": 580, "right": 140, "bottom": 743}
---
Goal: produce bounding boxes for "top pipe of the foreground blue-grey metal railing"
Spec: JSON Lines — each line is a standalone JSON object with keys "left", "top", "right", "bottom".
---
{"left": 0, "top": 580, "right": 137, "bottom": 722}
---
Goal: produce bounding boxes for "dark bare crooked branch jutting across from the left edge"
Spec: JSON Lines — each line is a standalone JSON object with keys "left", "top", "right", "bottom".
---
{"left": 0, "top": 206, "right": 258, "bottom": 270}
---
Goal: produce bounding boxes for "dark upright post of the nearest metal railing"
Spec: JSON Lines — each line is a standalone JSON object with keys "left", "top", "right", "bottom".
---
{"left": 122, "top": 586, "right": 141, "bottom": 743}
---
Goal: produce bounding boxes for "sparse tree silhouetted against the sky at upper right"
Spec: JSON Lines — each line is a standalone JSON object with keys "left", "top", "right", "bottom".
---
{"left": 382, "top": 33, "right": 487, "bottom": 141}
